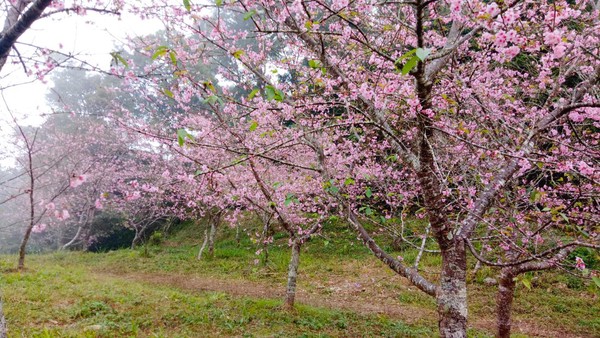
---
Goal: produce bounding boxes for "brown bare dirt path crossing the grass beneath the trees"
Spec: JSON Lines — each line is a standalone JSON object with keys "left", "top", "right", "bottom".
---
{"left": 102, "top": 268, "right": 581, "bottom": 338}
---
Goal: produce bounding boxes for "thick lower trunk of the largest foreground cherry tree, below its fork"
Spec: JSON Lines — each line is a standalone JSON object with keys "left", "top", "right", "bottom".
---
{"left": 437, "top": 240, "right": 467, "bottom": 338}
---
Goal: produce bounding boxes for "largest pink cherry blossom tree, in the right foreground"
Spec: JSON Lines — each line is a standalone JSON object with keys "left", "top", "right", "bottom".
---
{"left": 115, "top": 0, "right": 600, "bottom": 337}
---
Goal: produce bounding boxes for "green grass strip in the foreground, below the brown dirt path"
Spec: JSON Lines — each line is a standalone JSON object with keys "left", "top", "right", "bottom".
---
{"left": 2, "top": 254, "right": 433, "bottom": 337}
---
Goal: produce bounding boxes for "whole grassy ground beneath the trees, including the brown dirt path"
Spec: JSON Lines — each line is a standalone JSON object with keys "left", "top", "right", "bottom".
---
{"left": 0, "top": 220, "right": 600, "bottom": 337}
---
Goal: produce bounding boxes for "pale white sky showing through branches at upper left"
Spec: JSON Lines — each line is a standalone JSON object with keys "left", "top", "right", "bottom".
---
{"left": 0, "top": 2, "right": 164, "bottom": 166}
